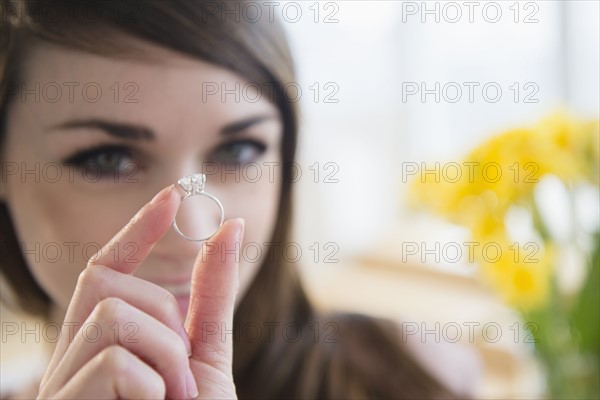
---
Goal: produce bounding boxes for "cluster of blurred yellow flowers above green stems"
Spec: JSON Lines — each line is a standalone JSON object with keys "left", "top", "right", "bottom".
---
{"left": 410, "top": 112, "right": 600, "bottom": 310}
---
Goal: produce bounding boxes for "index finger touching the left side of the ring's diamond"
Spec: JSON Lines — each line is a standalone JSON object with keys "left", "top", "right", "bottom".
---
{"left": 88, "top": 185, "right": 181, "bottom": 274}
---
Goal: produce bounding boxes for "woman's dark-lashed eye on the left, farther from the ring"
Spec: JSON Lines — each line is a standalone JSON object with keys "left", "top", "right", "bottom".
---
{"left": 63, "top": 145, "right": 135, "bottom": 178}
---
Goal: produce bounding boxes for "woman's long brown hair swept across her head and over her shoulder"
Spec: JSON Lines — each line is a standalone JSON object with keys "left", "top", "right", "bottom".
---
{"left": 0, "top": 0, "right": 460, "bottom": 399}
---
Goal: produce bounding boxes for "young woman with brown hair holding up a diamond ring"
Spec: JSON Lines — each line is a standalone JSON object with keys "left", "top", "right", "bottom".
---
{"left": 0, "top": 1, "right": 478, "bottom": 399}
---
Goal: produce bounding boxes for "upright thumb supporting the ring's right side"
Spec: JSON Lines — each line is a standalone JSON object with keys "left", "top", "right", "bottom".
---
{"left": 185, "top": 218, "right": 244, "bottom": 375}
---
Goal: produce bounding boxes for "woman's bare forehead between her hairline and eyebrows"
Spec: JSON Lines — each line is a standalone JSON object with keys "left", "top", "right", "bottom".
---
{"left": 13, "top": 39, "right": 277, "bottom": 136}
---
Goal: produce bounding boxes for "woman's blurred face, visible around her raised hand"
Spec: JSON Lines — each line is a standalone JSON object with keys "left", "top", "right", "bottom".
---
{"left": 2, "top": 39, "right": 282, "bottom": 318}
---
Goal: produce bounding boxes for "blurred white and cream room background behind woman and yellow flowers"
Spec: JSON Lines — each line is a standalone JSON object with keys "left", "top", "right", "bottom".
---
{"left": 281, "top": 1, "right": 600, "bottom": 398}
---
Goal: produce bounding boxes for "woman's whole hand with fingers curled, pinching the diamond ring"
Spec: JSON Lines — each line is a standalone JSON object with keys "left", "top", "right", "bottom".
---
{"left": 39, "top": 186, "right": 243, "bottom": 399}
